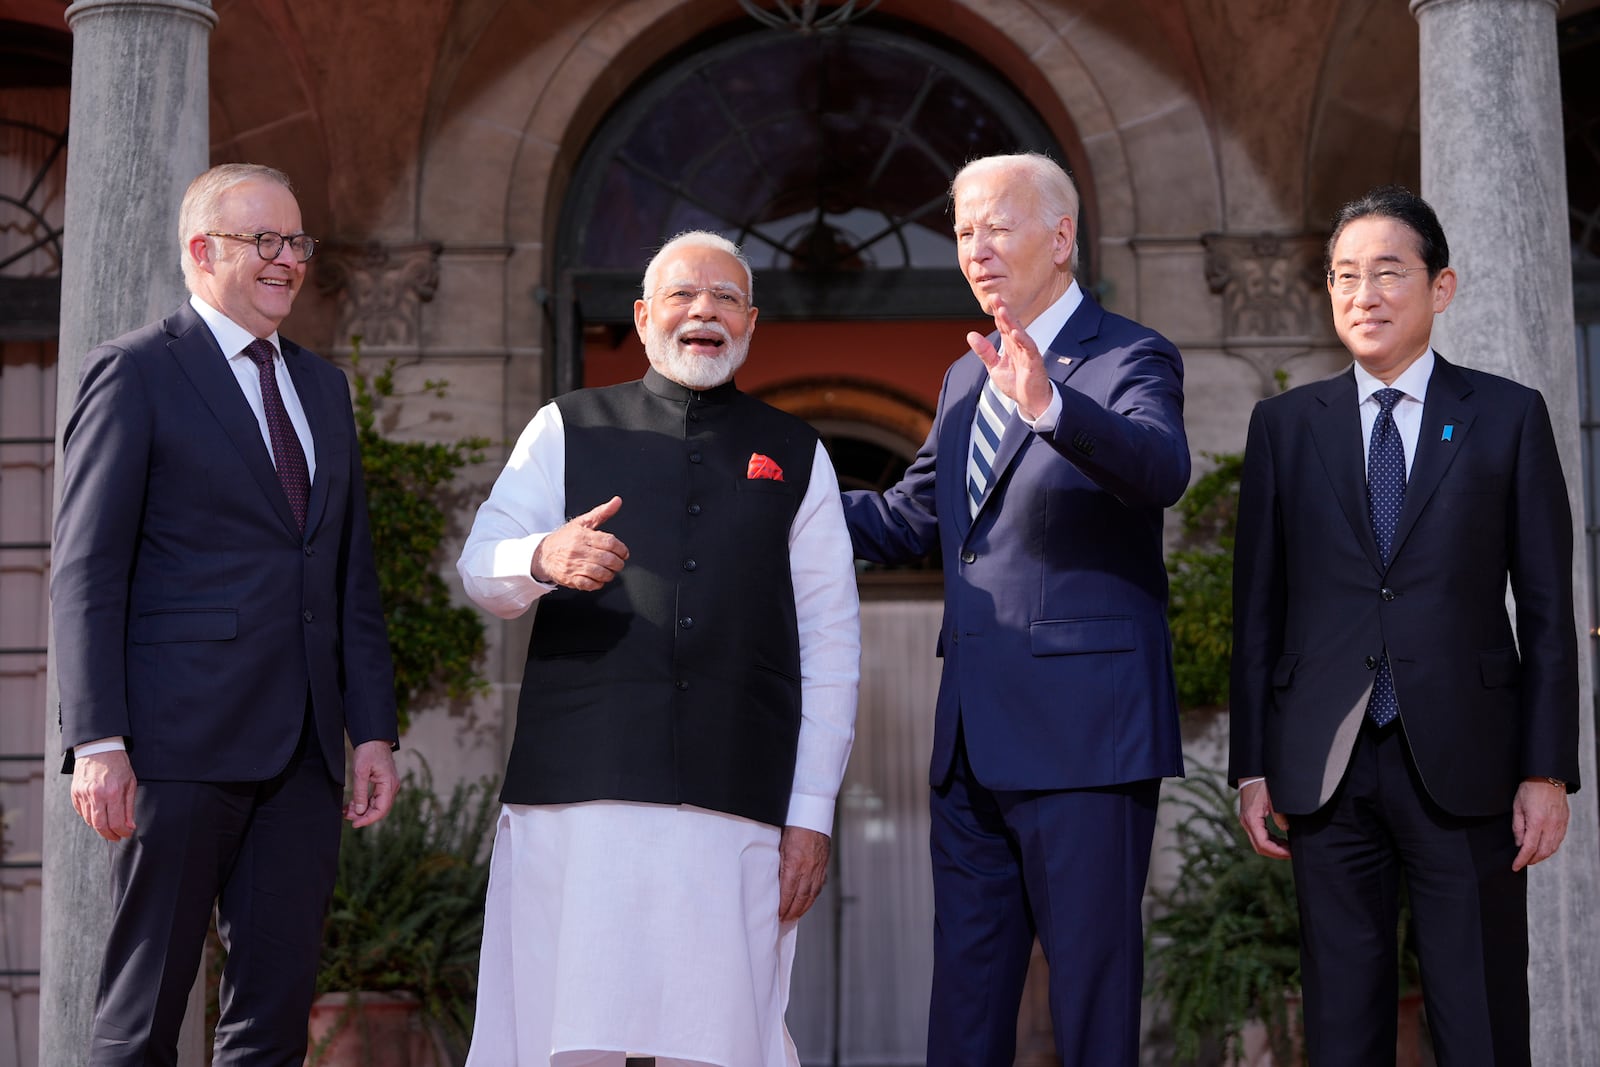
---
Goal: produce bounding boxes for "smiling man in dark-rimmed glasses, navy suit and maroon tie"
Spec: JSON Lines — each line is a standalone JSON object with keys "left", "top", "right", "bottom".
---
{"left": 51, "top": 165, "right": 398, "bottom": 1067}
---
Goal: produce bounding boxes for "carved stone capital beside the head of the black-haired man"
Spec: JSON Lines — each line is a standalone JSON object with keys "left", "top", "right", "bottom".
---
{"left": 1200, "top": 234, "right": 1333, "bottom": 394}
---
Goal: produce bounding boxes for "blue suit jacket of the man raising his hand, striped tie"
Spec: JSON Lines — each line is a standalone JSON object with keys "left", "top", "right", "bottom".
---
{"left": 845, "top": 294, "right": 1189, "bottom": 789}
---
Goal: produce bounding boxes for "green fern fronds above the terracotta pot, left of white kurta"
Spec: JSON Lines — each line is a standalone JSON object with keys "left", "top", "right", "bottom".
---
{"left": 312, "top": 763, "right": 499, "bottom": 1062}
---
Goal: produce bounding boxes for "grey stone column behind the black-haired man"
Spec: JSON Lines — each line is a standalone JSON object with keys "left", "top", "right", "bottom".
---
{"left": 1411, "top": 0, "right": 1600, "bottom": 1064}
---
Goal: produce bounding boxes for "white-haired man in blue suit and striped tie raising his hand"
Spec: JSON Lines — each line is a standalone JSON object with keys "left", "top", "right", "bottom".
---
{"left": 845, "top": 155, "right": 1189, "bottom": 1067}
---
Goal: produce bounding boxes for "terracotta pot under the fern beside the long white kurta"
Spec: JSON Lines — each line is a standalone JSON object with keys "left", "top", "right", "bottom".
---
{"left": 306, "top": 993, "right": 448, "bottom": 1067}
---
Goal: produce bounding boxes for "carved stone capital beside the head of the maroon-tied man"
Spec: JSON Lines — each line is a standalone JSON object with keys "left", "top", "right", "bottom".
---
{"left": 315, "top": 242, "right": 443, "bottom": 347}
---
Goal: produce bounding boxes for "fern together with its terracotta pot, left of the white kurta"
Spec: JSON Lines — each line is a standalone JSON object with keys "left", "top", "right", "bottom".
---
{"left": 307, "top": 763, "right": 499, "bottom": 1067}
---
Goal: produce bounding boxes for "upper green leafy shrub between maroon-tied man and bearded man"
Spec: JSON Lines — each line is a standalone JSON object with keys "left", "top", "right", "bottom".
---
{"left": 350, "top": 336, "right": 488, "bottom": 734}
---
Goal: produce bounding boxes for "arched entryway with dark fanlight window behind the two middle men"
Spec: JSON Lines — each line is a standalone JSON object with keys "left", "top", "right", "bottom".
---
{"left": 549, "top": 22, "right": 1093, "bottom": 1065}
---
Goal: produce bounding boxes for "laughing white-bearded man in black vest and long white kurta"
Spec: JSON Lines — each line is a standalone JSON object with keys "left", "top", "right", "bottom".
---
{"left": 456, "top": 232, "right": 861, "bottom": 1067}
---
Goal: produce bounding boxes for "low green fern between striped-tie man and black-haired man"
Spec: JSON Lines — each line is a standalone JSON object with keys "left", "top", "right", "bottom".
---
{"left": 1146, "top": 768, "right": 1299, "bottom": 1064}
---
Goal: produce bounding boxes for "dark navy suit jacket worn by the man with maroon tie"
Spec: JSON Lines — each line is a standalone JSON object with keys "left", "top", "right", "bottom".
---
{"left": 51, "top": 302, "right": 398, "bottom": 781}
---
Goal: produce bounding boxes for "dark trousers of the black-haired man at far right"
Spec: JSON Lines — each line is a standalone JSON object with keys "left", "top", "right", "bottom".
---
{"left": 1290, "top": 720, "right": 1530, "bottom": 1067}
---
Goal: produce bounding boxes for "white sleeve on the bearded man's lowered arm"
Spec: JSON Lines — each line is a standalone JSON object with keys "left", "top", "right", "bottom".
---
{"left": 786, "top": 443, "right": 861, "bottom": 833}
